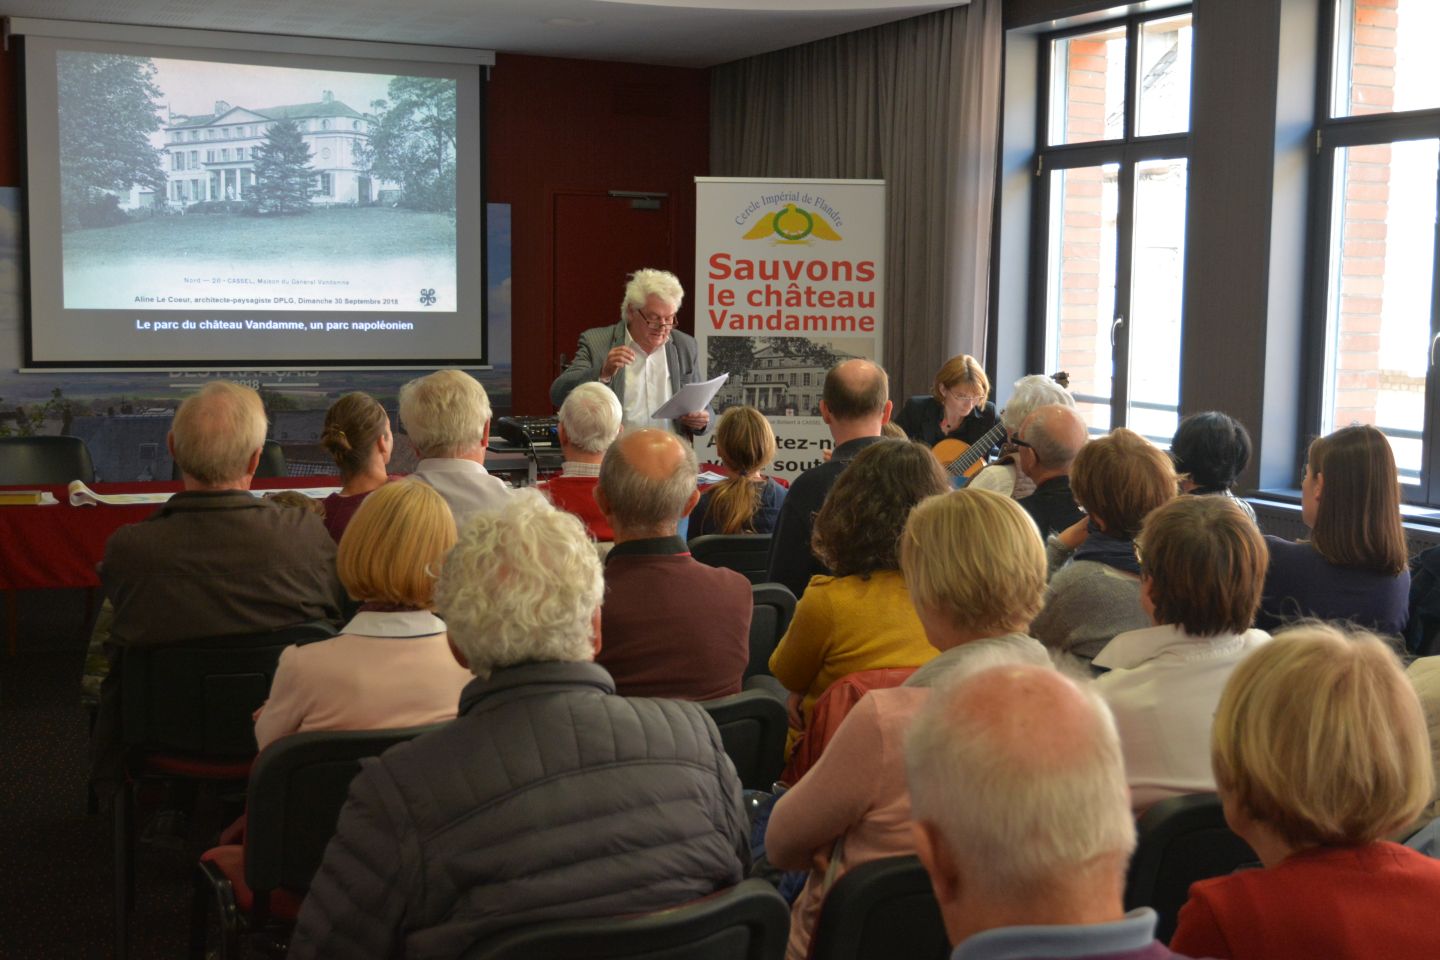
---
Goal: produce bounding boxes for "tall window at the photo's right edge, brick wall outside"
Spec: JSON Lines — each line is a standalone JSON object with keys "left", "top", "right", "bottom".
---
{"left": 1306, "top": 0, "right": 1440, "bottom": 505}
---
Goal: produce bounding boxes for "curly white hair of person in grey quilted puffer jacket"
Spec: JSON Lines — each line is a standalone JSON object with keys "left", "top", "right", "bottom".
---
{"left": 435, "top": 488, "right": 605, "bottom": 676}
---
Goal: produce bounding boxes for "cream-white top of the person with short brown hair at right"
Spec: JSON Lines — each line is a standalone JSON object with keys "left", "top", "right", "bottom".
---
{"left": 1094, "top": 625, "right": 1270, "bottom": 812}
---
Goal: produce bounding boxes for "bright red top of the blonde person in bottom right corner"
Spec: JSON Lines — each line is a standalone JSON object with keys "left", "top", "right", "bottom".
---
{"left": 1169, "top": 842, "right": 1440, "bottom": 960}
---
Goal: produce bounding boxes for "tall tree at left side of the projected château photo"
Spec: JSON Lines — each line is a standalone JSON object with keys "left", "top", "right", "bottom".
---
{"left": 58, "top": 53, "right": 166, "bottom": 230}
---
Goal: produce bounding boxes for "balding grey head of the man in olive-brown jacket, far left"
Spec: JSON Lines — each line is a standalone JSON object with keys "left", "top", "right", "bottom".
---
{"left": 170, "top": 380, "right": 265, "bottom": 484}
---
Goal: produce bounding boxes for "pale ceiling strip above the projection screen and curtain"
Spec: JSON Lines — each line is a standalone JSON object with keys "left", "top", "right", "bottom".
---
{"left": 0, "top": 0, "right": 969, "bottom": 68}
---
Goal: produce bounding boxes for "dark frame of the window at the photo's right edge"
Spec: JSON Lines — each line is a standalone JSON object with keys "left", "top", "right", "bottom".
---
{"left": 1295, "top": 0, "right": 1440, "bottom": 508}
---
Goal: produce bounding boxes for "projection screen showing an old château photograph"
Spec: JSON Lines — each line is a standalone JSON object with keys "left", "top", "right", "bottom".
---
{"left": 22, "top": 30, "right": 485, "bottom": 368}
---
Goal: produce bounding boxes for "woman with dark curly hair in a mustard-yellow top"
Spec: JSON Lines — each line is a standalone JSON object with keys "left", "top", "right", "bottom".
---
{"left": 770, "top": 440, "right": 950, "bottom": 753}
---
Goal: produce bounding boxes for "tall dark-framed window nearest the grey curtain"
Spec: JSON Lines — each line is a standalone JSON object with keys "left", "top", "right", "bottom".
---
{"left": 1028, "top": 9, "right": 1192, "bottom": 442}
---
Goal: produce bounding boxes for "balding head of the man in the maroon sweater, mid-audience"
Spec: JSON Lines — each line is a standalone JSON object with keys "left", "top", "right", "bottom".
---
{"left": 595, "top": 429, "right": 700, "bottom": 543}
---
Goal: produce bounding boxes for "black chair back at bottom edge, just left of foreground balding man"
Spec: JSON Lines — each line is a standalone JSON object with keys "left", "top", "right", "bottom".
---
{"left": 811, "top": 856, "right": 950, "bottom": 960}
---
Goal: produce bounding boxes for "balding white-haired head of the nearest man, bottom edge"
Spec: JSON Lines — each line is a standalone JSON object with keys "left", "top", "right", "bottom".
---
{"left": 906, "top": 666, "right": 1135, "bottom": 898}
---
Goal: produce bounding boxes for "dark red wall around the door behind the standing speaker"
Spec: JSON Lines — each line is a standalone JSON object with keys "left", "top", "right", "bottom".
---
{"left": 485, "top": 55, "right": 710, "bottom": 413}
